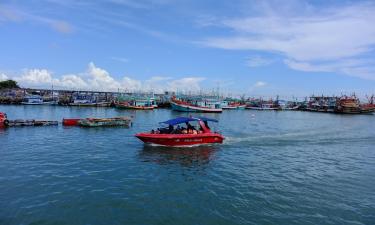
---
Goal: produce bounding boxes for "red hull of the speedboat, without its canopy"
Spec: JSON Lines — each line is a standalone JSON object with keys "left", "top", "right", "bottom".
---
{"left": 135, "top": 133, "right": 224, "bottom": 147}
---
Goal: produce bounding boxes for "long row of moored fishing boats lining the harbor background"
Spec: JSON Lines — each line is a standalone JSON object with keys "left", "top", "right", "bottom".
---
{"left": 0, "top": 88, "right": 375, "bottom": 114}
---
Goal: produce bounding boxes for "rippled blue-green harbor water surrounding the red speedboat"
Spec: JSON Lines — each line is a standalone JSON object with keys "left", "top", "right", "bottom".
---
{"left": 0, "top": 105, "right": 375, "bottom": 225}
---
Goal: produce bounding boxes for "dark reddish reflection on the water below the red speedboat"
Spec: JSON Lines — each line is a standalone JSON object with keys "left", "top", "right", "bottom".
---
{"left": 140, "top": 145, "right": 219, "bottom": 167}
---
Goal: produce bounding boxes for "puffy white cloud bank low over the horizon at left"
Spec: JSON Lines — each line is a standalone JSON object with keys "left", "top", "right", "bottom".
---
{"left": 0, "top": 62, "right": 205, "bottom": 93}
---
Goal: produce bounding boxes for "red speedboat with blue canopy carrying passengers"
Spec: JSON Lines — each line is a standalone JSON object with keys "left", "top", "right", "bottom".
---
{"left": 135, "top": 117, "right": 224, "bottom": 147}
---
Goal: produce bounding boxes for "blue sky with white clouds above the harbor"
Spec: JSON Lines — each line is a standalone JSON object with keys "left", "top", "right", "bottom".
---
{"left": 0, "top": 0, "right": 375, "bottom": 97}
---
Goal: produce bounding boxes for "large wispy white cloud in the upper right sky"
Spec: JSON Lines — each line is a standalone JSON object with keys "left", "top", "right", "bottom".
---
{"left": 201, "top": 1, "right": 375, "bottom": 79}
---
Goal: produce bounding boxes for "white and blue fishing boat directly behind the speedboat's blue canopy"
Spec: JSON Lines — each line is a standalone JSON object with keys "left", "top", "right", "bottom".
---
{"left": 170, "top": 97, "right": 223, "bottom": 113}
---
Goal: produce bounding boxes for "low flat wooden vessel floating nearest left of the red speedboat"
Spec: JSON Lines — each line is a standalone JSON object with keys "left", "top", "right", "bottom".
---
{"left": 78, "top": 117, "right": 131, "bottom": 127}
